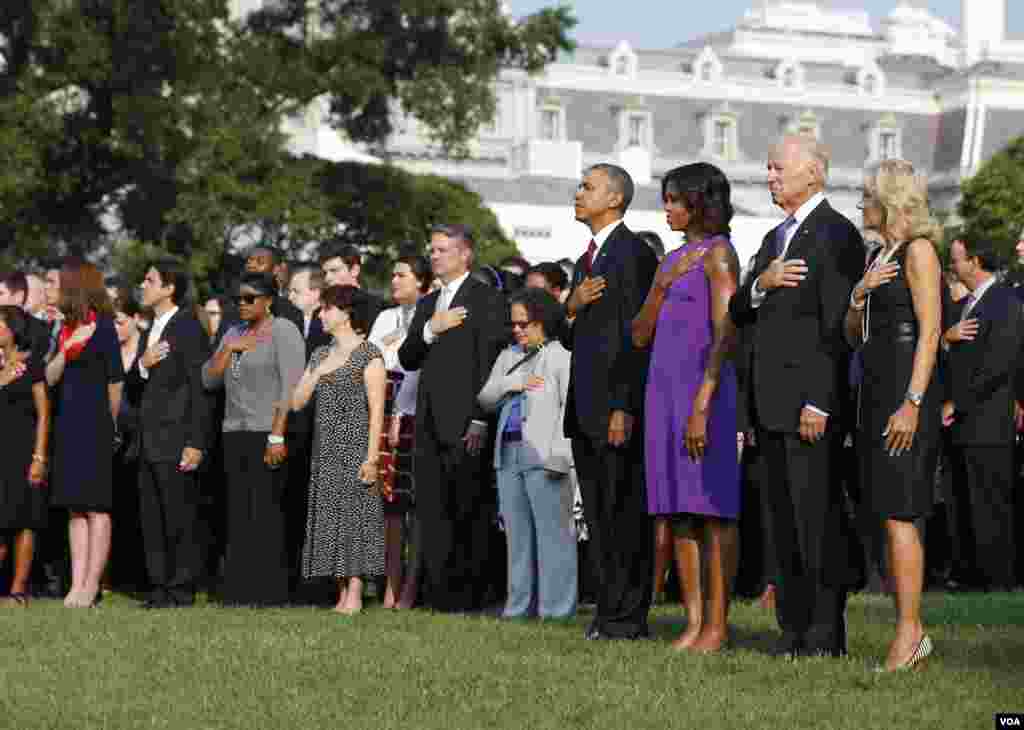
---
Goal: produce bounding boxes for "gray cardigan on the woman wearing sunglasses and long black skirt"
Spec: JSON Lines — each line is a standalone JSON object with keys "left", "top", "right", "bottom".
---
{"left": 203, "top": 317, "right": 306, "bottom": 433}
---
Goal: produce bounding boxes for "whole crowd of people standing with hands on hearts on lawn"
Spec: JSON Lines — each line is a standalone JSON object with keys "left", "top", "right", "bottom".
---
{"left": 0, "top": 136, "right": 1024, "bottom": 671}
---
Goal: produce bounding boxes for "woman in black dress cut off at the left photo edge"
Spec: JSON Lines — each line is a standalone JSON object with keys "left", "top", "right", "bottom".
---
{"left": 0, "top": 306, "right": 50, "bottom": 606}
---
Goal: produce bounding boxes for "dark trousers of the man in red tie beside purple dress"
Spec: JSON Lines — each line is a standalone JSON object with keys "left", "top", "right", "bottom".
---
{"left": 572, "top": 429, "right": 654, "bottom": 638}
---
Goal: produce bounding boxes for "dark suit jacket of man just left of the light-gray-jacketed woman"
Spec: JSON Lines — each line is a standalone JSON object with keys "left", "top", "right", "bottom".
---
{"left": 398, "top": 276, "right": 505, "bottom": 447}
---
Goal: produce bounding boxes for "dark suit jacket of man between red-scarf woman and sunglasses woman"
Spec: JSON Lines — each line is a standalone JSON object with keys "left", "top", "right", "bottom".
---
{"left": 138, "top": 310, "right": 213, "bottom": 462}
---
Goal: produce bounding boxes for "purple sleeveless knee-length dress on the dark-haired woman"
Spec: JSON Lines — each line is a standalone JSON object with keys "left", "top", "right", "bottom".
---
{"left": 645, "top": 237, "right": 739, "bottom": 519}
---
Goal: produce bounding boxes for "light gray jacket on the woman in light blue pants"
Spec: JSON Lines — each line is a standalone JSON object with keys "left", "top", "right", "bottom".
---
{"left": 477, "top": 341, "right": 572, "bottom": 474}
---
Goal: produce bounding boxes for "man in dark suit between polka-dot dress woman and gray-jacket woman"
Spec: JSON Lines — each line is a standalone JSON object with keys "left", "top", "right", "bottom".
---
{"left": 398, "top": 225, "right": 505, "bottom": 611}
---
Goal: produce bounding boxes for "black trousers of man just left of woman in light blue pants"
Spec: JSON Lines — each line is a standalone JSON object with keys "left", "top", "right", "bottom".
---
{"left": 416, "top": 425, "right": 494, "bottom": 612}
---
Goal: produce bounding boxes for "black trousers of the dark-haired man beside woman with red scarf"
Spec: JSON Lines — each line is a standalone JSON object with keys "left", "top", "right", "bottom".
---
{"left": 138, "top": 457, "right": 203, "bottom": 605}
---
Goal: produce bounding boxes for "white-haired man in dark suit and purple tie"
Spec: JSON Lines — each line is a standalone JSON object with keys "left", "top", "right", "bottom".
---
{"left": 729, "top": 136, "right": 864, "bottom": 656}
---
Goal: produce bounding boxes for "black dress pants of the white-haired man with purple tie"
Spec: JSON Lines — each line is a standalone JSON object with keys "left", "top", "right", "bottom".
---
{"left": 759, "top": 430, "right": 855, "bottom": 656}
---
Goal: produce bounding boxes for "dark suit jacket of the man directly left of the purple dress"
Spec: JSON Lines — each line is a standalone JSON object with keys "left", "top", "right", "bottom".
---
{"left": 565, "top": 223, "right": 657, "bottom": 441}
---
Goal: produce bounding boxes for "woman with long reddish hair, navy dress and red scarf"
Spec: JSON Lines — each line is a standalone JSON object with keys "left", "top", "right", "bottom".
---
{"left": 46, "top": 258, "right": 124, "bottom": 608}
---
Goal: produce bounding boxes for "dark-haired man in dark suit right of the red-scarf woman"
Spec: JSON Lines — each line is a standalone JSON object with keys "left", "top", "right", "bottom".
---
{"left": 138, "top": 261, "right": 212, "bottom": 608}
